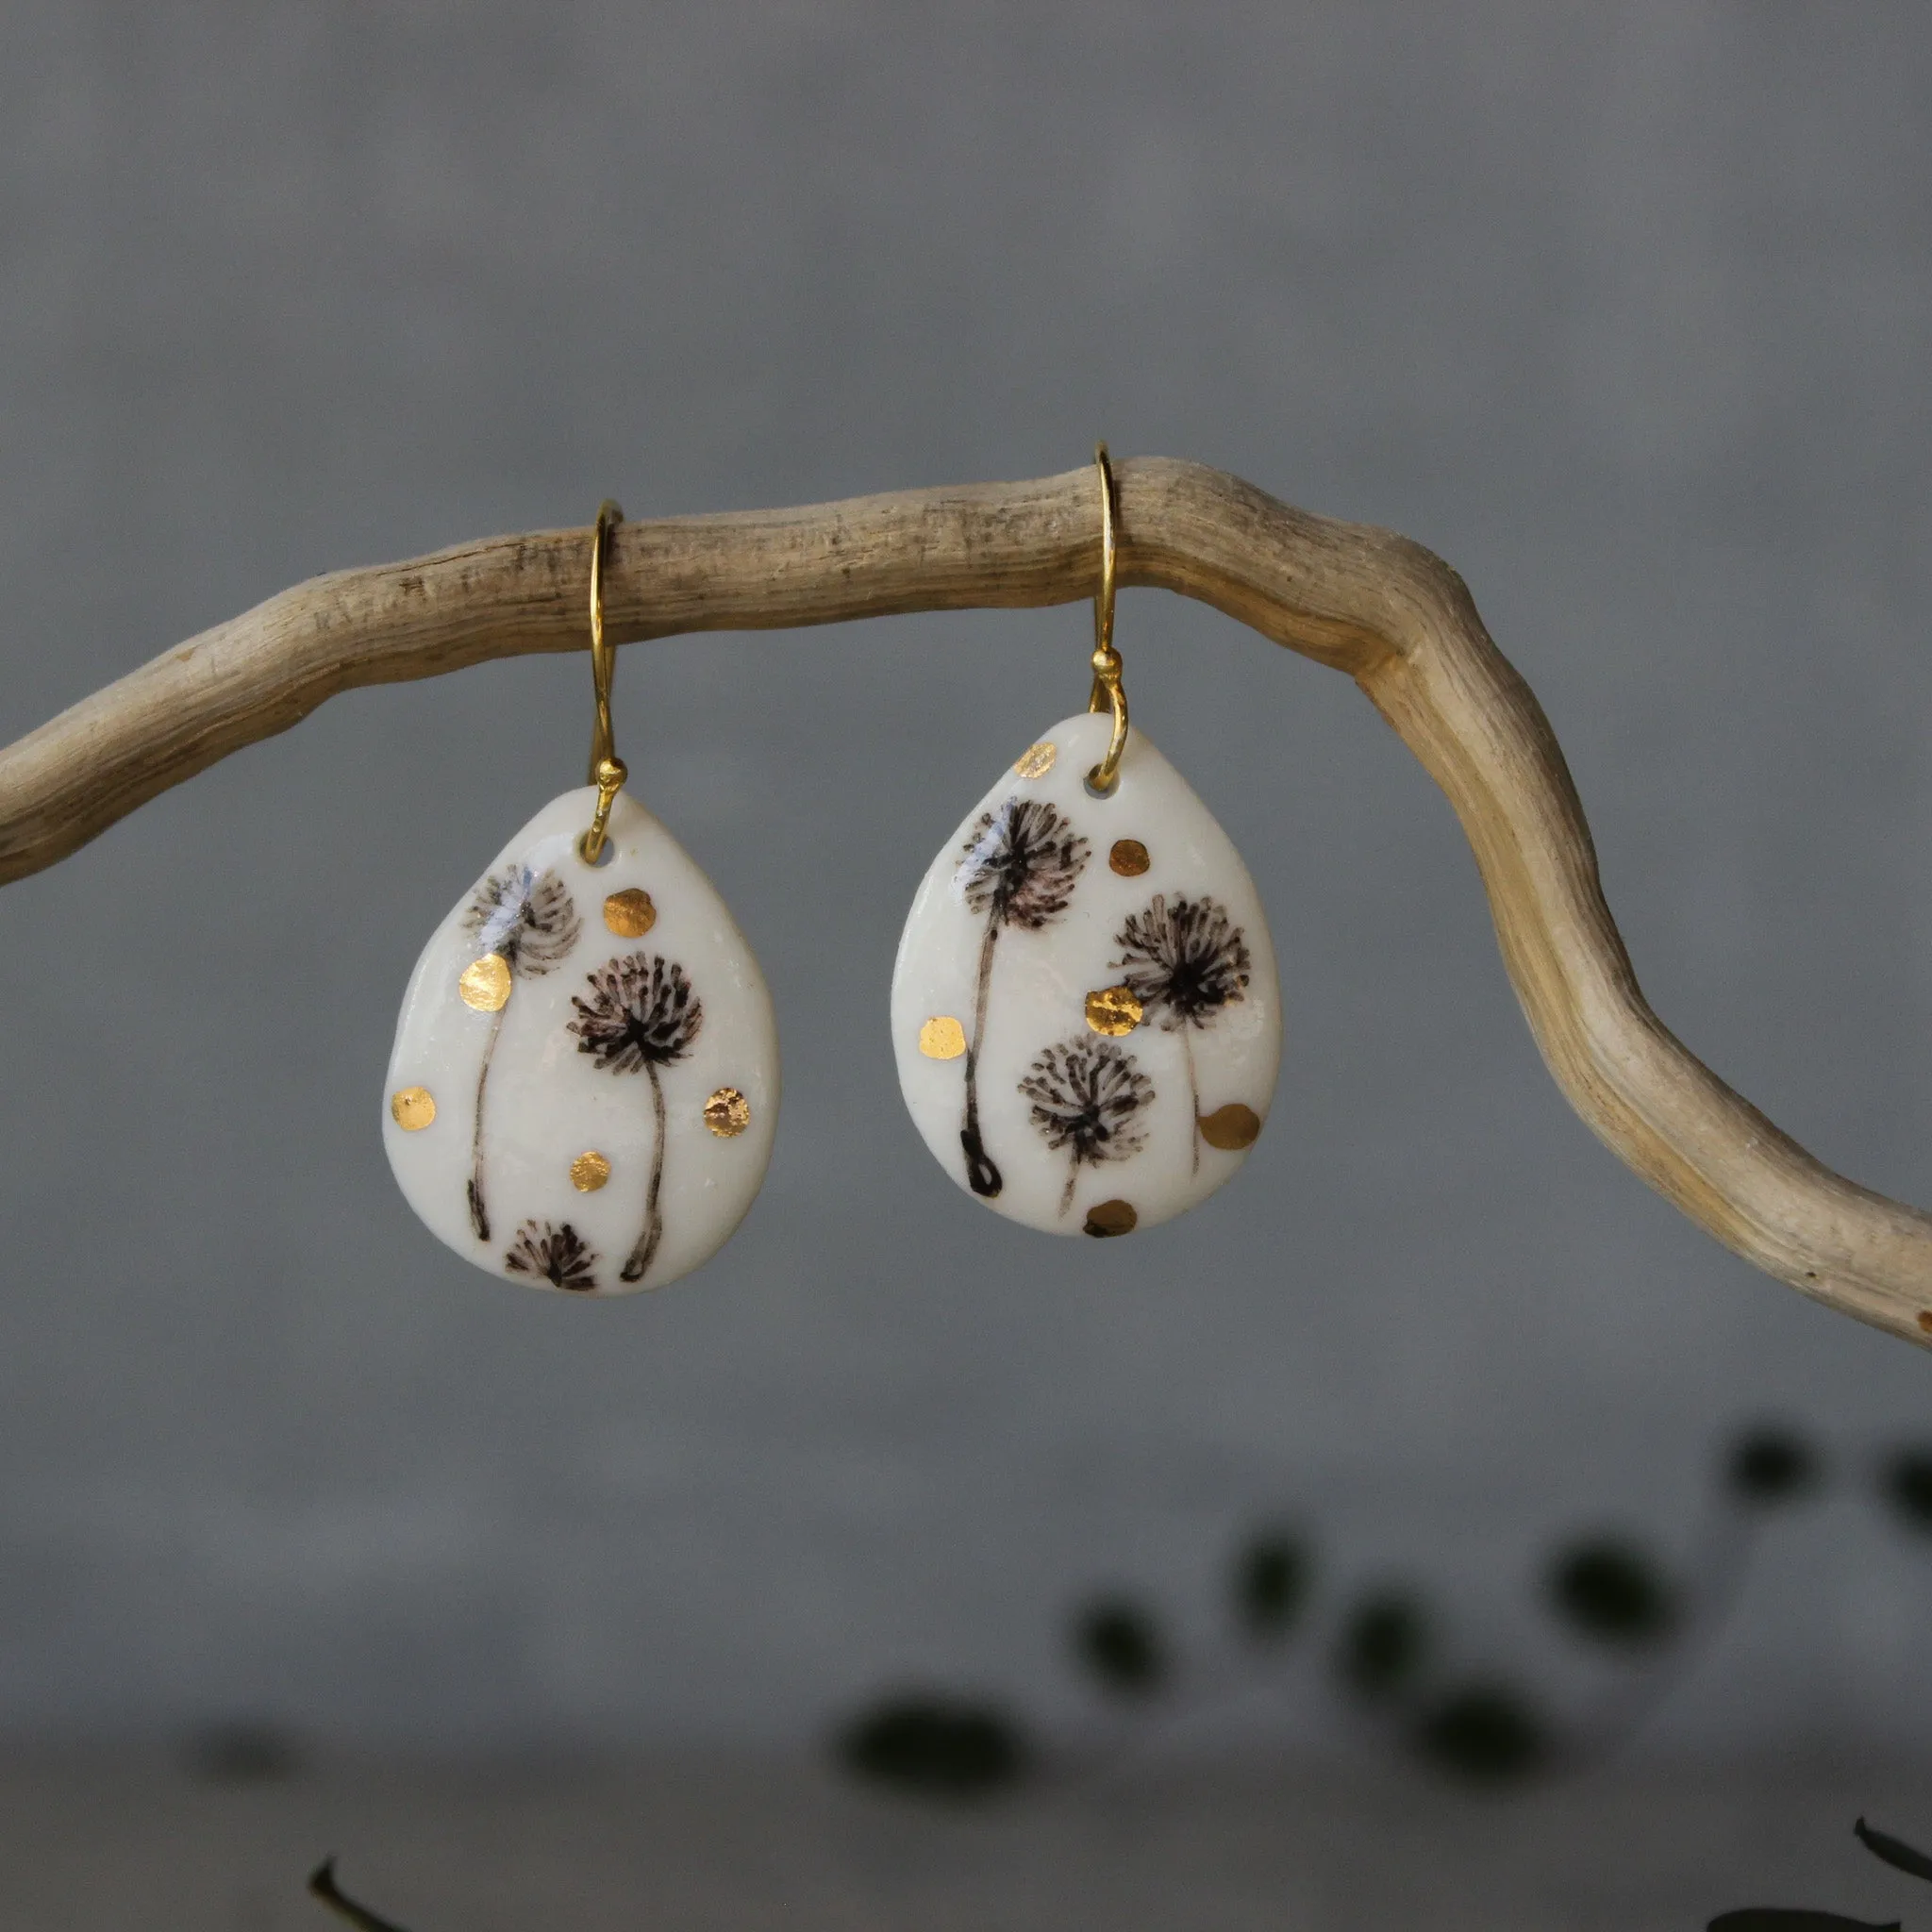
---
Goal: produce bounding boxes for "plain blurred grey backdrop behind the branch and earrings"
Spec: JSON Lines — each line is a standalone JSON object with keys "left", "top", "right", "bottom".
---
{"left": 0, "top": 0, "right": 1932, "bottom": 1750}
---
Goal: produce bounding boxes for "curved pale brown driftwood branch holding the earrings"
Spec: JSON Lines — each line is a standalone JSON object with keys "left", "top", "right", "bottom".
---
{"left": 0, "top": 458, "right": 1932, "bottom": 1342}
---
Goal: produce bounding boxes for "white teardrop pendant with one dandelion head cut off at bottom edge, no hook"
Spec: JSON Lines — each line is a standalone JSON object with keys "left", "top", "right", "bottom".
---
{"left": 383, "top": 787, "right": 778, "bottom": 1294}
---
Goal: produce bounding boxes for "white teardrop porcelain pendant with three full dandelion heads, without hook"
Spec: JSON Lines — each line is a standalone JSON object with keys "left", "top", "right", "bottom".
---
{"left": 892, "top": 713, "right": 1281, "bottom": 1235}
